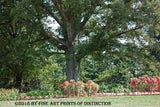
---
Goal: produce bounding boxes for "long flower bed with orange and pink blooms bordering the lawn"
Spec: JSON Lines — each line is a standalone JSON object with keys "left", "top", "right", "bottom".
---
{"left": 0, "top": 75, "right": 160, "bottom": 101}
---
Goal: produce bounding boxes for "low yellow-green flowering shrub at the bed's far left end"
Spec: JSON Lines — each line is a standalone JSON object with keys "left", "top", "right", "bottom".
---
{"left": 0, "top": 88, "right": 19, "bottom": 100}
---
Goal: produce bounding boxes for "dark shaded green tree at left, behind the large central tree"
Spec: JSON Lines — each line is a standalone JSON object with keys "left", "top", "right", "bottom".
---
{"left": 0, "top": 0, "right": 53, "bottom": 89}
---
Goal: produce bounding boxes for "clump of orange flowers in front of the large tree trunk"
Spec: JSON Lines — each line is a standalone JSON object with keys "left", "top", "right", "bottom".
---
{"left": 60, "top": 80, "right": 98, "bottom": 97}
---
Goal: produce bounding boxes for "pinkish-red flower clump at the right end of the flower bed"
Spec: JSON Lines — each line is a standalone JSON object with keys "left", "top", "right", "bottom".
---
{"left": 132, "top": 75, "right": 160, "bottom": 92}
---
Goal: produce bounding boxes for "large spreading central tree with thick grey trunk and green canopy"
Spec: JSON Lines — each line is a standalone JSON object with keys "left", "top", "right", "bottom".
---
{"left": 10, "top": 0, "right": 160, "bottom": 81}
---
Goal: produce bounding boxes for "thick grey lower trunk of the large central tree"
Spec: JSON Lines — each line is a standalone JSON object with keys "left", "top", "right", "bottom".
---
{"left": 66, "top": 51, "right": 81, "bottom": 81}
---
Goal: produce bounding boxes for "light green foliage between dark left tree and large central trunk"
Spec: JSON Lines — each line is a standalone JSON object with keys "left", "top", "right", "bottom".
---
{"left": 36, "top": 55, "right": 66, "bottom": 90}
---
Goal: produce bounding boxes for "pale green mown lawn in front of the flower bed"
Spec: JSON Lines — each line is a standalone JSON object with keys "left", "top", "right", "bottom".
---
{"left": 0, "top": 95, "right": 160, "bottom": 107}
